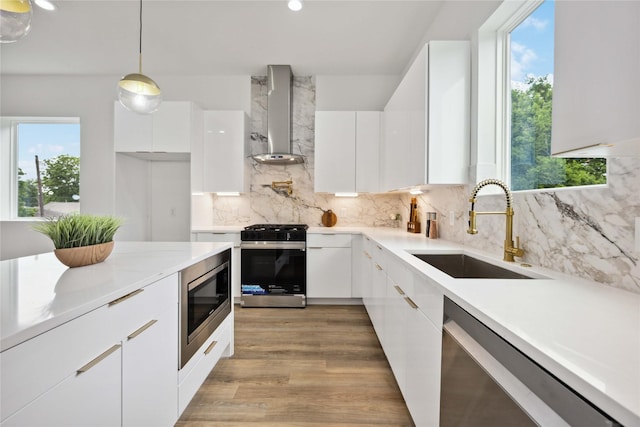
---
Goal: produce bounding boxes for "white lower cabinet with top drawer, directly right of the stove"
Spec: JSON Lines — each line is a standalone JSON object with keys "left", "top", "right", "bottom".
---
{"left": 307, "top": 234, "right": 352, "bottom": 298}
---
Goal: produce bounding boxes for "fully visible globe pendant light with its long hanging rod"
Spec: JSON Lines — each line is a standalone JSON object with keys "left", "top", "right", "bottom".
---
{"left": 118, "top": 0, "right": 162, "bottom": 114}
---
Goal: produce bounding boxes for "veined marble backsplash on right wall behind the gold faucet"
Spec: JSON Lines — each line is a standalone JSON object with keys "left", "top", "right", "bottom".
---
{"left": 410, "top": 158, "right": 640, "bottom": 293}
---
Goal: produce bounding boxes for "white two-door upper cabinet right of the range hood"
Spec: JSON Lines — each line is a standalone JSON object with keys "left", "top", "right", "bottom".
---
{"left": 314, "top": 111, "right": 381, "bottom": 193}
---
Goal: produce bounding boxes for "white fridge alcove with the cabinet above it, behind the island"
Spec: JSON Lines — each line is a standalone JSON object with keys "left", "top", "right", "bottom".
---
{"left": 114, "top": 101, "right": 203, "bottom": 241}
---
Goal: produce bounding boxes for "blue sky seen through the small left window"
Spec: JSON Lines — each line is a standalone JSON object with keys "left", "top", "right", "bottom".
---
{"left": 18, "top": 123, "right": 80, "bottom": 180}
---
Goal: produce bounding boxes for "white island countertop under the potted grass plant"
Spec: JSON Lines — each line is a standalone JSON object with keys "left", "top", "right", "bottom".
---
{"left": 0, "top": 242, "right": 232, "bottom": 351}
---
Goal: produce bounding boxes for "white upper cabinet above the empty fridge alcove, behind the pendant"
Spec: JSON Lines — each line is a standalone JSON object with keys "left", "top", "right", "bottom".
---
{"left": 113, "top": 101, "right": 202, "bottom": 160}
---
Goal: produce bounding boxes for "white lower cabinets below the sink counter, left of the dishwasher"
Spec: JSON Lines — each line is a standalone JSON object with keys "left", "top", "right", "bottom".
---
{"left": 362, "top": 242, "right": 443, "bottom": 427}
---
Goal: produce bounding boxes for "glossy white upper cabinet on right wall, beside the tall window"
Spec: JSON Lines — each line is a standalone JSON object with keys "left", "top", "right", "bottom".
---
{"left": 380, "top": 41, "right": 471, "bottom": 191}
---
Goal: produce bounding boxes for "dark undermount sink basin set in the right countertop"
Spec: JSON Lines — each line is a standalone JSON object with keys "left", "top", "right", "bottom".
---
{"left": 412, "top": 254, "right": 534, "bottom": 279}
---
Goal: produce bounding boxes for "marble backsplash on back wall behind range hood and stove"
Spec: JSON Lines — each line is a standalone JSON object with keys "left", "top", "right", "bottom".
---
{"left": 193, "top": 76, "right": 402, "bottom": 231}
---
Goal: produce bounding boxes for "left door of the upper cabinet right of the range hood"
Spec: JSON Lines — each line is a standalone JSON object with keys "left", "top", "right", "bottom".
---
{"left": 314, "top": 111, "right": 356, "bottom": 193}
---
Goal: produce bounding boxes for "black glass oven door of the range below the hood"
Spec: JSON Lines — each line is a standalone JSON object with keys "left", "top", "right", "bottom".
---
{"left": 240, "top": 243, "right": 307, "bottom": 295}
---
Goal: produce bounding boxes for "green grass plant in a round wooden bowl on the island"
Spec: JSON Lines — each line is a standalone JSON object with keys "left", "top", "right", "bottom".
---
{"left": 33, "top": 214, "right": 122, "bottom": 267}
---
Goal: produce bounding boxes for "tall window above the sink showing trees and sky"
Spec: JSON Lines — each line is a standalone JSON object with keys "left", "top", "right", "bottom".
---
{"left": 503, "top": 0, "right": 606, "bottom": 190}
